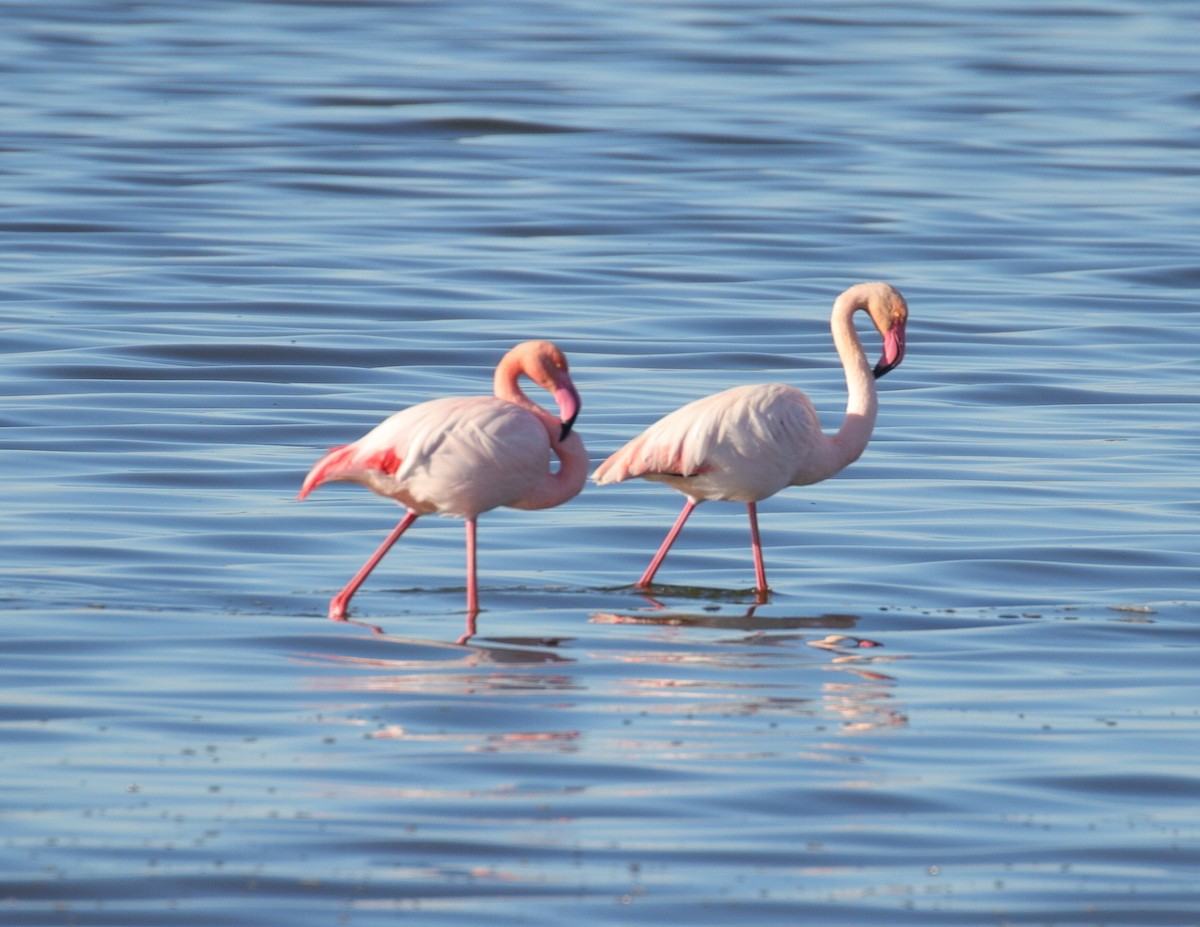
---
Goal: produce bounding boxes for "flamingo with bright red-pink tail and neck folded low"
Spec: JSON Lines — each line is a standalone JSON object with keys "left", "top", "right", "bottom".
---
{"left": 296, "top": 341, "right": 588, "bottom": 640}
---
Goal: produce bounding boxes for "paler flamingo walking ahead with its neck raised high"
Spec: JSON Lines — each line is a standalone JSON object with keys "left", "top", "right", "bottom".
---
{"left": 592, "top": 283, "right": 908, "bottom": 598}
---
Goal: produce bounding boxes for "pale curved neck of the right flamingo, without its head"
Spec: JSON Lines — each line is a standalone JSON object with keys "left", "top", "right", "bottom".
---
{"left": 808, "top": 287, "right": 878, "bottom": 480}
